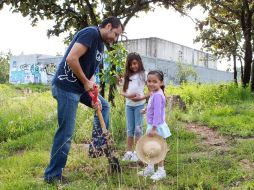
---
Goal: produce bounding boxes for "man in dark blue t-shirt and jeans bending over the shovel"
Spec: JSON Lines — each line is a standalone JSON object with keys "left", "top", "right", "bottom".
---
{"left": 44, "top": 17, "right": 124, "bottom": 183}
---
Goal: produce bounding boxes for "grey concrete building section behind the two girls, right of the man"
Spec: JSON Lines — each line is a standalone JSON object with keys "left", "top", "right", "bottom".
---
{"left": 123, "top": 37, "right": 233, "bottom": 84}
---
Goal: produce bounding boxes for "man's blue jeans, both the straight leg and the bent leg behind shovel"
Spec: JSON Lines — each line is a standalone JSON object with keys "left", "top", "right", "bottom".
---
{"left": 44, "top": 85, "right": 110, "bottom": 181}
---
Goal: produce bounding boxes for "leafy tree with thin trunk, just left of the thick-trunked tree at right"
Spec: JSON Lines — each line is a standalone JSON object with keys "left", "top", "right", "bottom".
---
{"left": 195, "top": 9, "right": 243, "bottom": 84}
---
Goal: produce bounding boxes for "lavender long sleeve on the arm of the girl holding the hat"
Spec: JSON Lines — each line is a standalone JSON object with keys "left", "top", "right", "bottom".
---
{"left": 153, "top": 94, "right": 163, "bottom": 126}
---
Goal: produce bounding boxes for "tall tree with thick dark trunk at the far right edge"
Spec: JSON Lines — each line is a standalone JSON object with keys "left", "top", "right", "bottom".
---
{"left": 190, "top": 0, "right": 254, "bottom": 91}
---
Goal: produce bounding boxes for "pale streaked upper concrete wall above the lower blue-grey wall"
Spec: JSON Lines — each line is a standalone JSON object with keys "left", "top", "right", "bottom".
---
{"left": 123, "top": 38, "right": 217, "bottom": 69}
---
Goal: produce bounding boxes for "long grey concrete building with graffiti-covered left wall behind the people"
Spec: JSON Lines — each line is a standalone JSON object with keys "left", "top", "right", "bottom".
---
{"left": 10, "top": 38, "right": 233, "bottom": 84}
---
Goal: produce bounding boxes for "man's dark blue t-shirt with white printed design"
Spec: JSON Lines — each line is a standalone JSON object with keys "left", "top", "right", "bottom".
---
{"left": 52, "top": 26, "right": 104, "bottom": 93}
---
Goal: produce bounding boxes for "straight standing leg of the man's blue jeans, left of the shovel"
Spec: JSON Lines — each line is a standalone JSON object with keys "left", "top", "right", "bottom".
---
{"left": 44, "top": 85, "right": 81, "bottom": 181}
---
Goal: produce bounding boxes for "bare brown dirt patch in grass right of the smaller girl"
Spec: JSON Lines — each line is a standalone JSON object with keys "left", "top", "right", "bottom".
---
{"left": 186, "top": 123, "right": 230, "bottom": 151}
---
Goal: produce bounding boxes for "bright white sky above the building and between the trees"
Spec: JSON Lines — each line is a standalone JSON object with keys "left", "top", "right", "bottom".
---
{"left": 0, "top": 7, "right": 226, "bottom": 70}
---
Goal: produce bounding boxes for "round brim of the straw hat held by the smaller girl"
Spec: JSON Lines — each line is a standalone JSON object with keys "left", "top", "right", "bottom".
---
{"left": 136, "top": 134, "right": 168, "bottom": 164}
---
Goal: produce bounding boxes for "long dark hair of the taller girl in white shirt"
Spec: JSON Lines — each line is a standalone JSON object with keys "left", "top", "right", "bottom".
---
{"left": 123, "top": 52, "right": 145, "bottom": 92}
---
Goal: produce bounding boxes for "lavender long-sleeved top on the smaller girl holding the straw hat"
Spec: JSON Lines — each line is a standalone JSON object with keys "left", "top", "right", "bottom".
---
{"left": 146, "top": 89, "right": 166, "bottom": 126}
